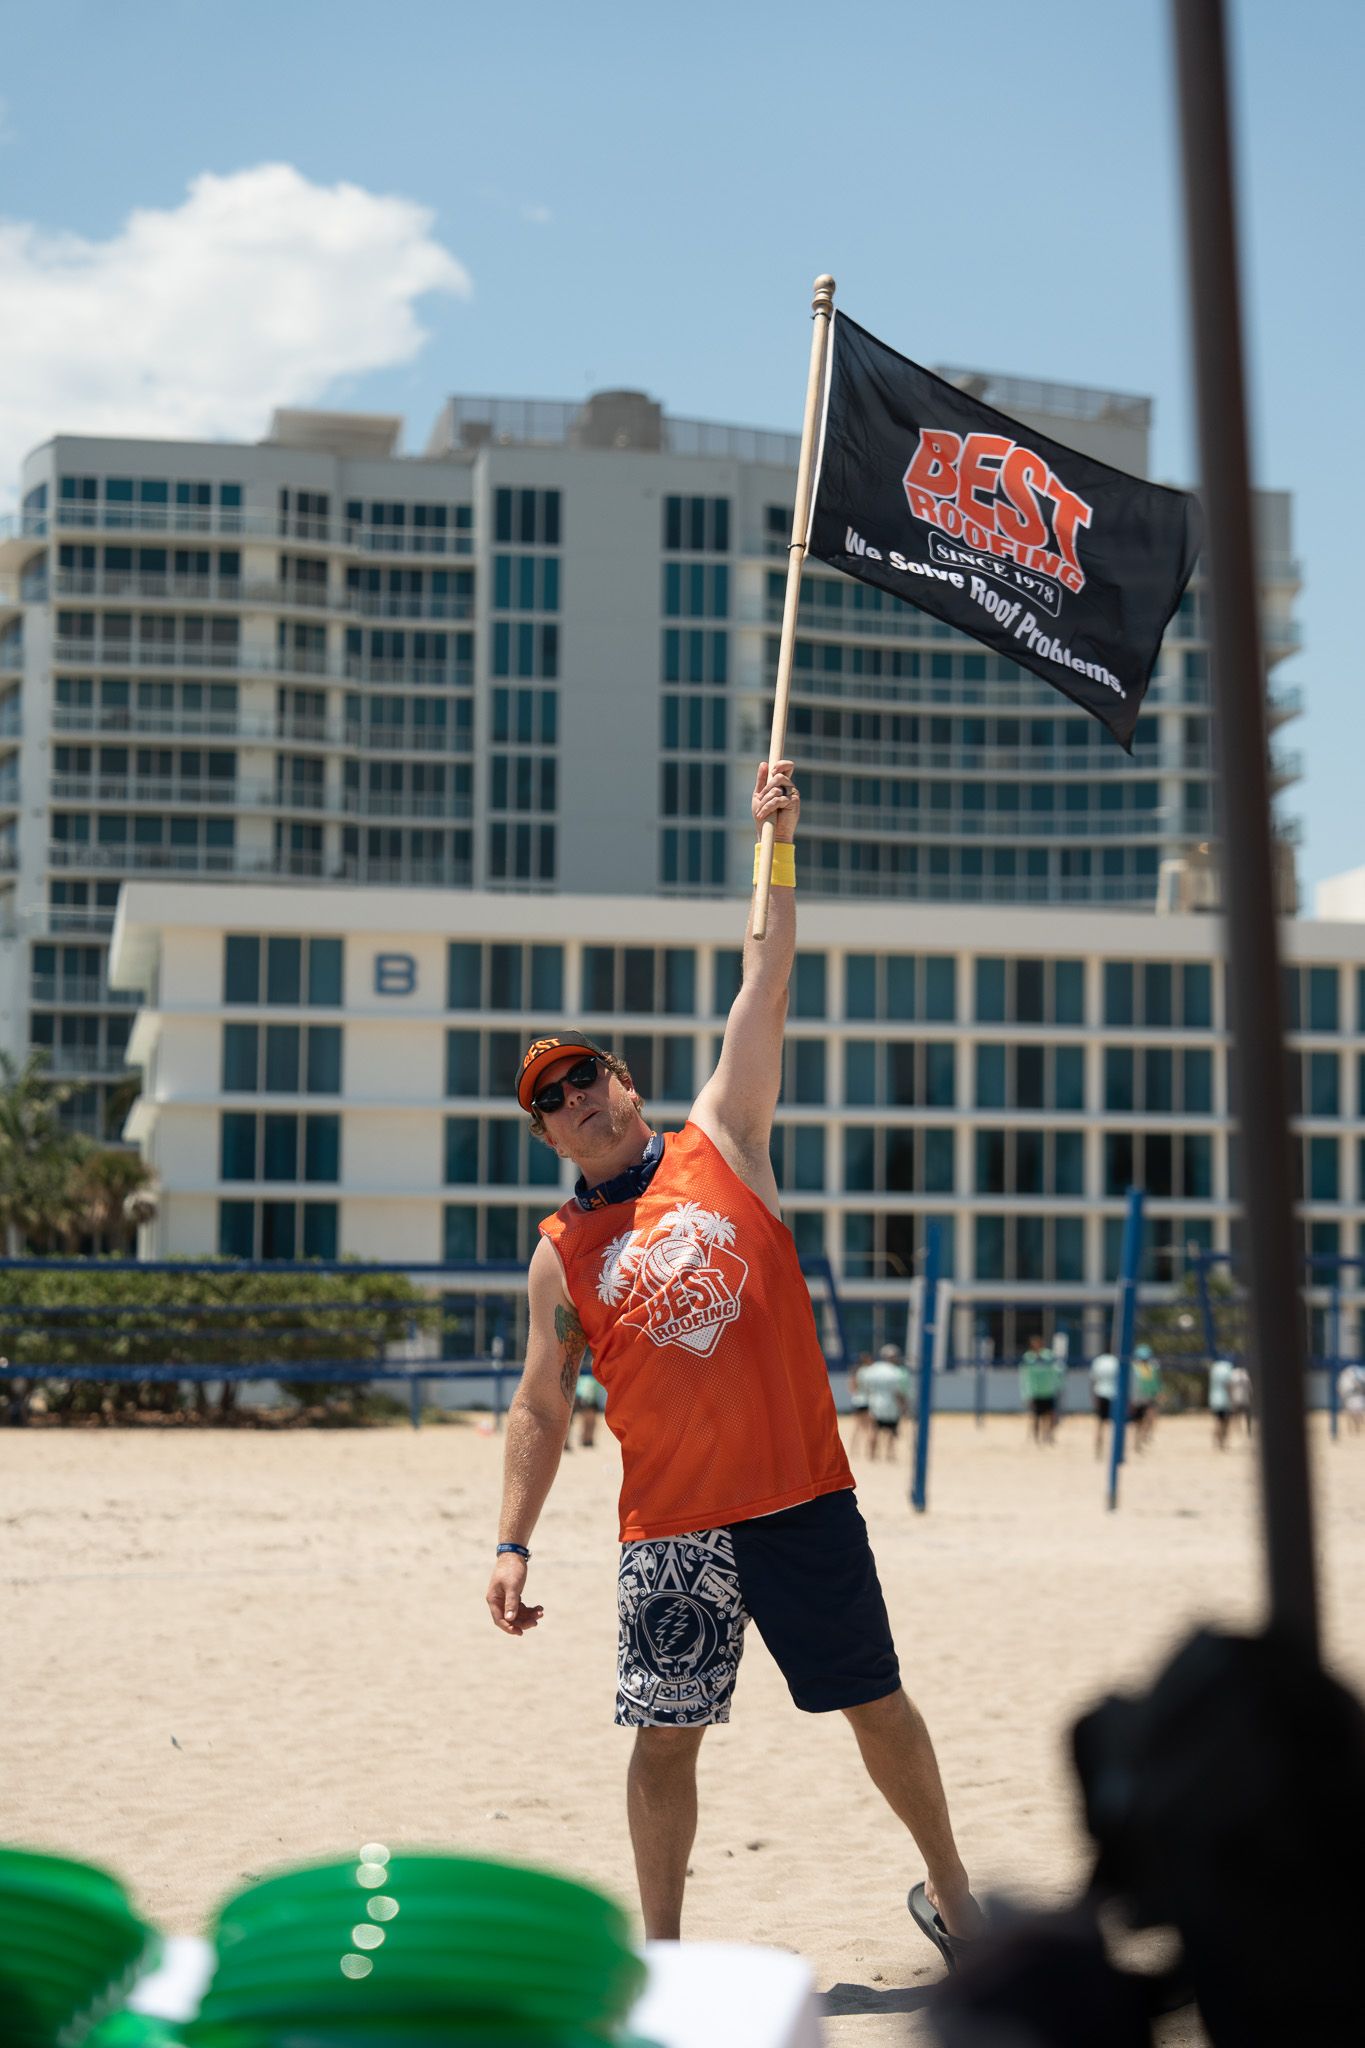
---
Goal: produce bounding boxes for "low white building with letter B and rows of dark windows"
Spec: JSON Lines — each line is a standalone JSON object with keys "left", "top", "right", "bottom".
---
{"left": 111, "top": 876, "right": 1365, "bottom": 1356}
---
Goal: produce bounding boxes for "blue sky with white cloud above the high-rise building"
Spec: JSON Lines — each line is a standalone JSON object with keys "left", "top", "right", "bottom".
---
{"left": 0, "top": 0, "right": 1365, "bottom": 883}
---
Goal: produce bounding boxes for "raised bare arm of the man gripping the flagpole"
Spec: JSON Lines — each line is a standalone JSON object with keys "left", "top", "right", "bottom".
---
{"left": 692, "top": 762, "right": 800, "bottom": 1214}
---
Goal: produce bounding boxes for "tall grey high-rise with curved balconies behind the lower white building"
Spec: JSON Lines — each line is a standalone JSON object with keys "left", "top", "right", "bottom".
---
{"left": 0, "top": 377, "right": 1297, "bottom": 1130}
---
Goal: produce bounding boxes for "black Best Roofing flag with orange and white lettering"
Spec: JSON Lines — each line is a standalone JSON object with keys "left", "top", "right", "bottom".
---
{"left": 810, "top": 313, "right": 1199, "bottom": 752}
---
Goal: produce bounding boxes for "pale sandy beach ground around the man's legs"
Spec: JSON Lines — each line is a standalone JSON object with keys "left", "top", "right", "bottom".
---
{"left": 0, "top": 1417, "right": 1365, "bottom": 2048}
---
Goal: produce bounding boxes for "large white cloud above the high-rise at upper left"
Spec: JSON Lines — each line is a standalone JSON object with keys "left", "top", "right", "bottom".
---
{"left": 0, "top": 164, "right": 471, "bottom": 496}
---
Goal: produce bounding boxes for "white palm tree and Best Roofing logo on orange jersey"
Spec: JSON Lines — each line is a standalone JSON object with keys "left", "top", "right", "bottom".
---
{"left": 598, "top": 1202, "right": 749, "bottom": 1358}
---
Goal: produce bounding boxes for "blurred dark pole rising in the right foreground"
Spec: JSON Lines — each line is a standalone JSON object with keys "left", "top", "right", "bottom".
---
{"left": 1171, "top": 0, "right": 1318, "bottom": 1655}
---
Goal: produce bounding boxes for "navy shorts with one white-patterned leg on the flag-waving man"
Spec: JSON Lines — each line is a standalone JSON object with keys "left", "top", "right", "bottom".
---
{"left": 616, "top": 1491, "right": 900, "bottom": 1729}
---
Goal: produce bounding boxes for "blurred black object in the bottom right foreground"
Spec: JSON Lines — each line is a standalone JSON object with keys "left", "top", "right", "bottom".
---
{"left": 935, "top": 1632, "right": 1365, "bottom": 2048}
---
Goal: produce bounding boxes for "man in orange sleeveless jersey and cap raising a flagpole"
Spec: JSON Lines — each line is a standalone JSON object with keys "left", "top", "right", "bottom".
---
{"left": 487, "top": 760, "right": 980, "bottom": 1966}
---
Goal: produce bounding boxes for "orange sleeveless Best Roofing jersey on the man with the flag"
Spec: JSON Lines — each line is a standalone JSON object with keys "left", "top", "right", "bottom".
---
{"left": 540, "top": 1124, "right": 853, "bottom": 1542}
